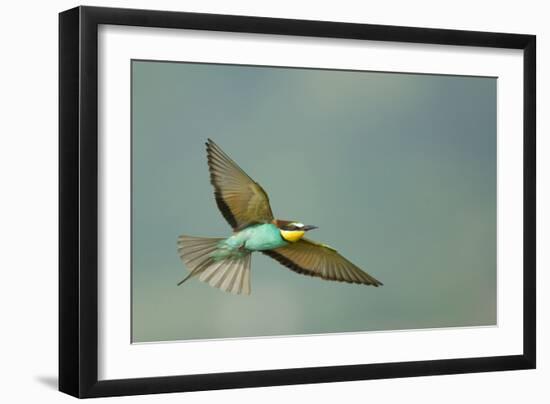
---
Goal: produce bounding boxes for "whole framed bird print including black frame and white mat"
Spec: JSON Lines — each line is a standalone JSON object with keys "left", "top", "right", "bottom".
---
{"left": 59, "top": 7, "right": 536, "bottom": 397}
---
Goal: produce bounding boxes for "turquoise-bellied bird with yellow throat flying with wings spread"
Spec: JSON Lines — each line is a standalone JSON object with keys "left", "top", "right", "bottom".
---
{"left": 177, "top": 139, "right": 382, "bottom": 295}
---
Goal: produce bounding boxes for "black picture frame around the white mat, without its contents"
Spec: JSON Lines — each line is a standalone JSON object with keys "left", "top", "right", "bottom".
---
{"left": 59, "top": 7, "right": 536, "bottom": 398}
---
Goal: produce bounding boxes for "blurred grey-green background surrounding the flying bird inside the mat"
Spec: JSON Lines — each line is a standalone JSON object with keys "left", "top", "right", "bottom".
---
{"left": 132, "top": 61, "right": 497, "bottom": 342}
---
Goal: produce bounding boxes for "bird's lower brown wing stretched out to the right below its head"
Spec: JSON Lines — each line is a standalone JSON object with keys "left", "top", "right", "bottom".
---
{"left": 262, "top": 239, "right": 382, "bottom": 286}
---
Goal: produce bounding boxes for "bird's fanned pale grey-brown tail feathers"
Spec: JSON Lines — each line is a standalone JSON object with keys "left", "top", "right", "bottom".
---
{"left": 178, "top": 236, "right": 251, "bottom": 295}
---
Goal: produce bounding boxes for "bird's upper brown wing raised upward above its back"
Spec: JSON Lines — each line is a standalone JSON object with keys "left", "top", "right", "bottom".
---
{"left": 206, "top": 139, "right": 273, "bottom": 230}
